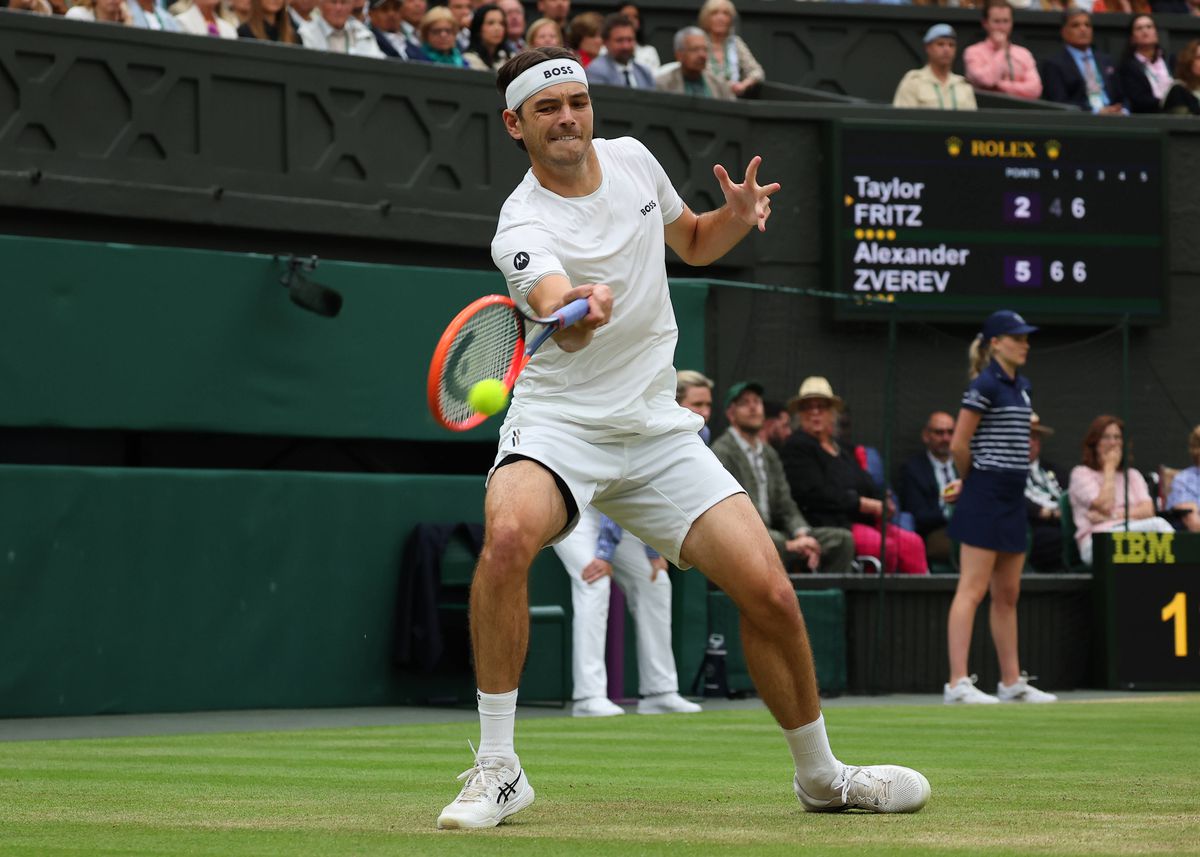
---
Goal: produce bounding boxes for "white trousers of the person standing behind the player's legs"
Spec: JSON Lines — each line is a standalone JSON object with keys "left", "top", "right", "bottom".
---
{"left": 554, "top": 508, "right": 679, "bottom": 700}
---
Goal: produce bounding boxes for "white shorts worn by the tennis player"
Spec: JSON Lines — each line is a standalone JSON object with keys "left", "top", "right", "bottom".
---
{"left": 487, "top": 426, "right": 744, "bottom": 569}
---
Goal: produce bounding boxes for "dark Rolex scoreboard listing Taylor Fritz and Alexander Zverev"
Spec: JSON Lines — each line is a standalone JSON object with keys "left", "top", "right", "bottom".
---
{"left": 832, "top": 121, "right": 1166, "bottom": 322}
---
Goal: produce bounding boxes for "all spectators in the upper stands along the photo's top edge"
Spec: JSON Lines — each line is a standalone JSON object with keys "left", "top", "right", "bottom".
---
{"left": 9, "top": 0, "right": 1200, "bottom": 115}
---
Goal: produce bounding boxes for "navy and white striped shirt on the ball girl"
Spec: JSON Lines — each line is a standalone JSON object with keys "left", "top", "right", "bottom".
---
{"left": 962, "top": 360, "right": 1033, "bottom": 475}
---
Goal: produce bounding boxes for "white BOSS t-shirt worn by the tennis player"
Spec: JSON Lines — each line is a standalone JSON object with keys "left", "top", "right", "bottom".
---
{"left": 492, "top": 137, "right": 703, "bottom": 442}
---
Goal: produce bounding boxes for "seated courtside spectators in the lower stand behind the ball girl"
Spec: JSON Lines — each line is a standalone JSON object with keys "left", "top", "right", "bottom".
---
{"left": 709, "top": 377, "right": 1200, "bottom": 574}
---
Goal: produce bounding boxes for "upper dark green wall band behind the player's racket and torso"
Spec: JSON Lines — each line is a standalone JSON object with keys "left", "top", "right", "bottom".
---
{"left": 0, "top": 236, "right": 707, "bottom": 442}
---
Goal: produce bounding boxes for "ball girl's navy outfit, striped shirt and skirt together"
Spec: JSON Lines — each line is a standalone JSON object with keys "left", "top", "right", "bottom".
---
{"left": 948, "top": 360, "right": 1032, "bottom": 553}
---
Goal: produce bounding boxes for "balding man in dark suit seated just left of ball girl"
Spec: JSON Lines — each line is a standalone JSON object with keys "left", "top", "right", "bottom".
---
{"left": 900, "top": 410, "right": 962, "bottom": 563}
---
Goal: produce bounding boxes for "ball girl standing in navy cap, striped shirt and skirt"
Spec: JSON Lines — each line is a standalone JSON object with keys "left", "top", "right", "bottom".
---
{"left": 942, "top": 310, "right": 1058, "bottom": 705}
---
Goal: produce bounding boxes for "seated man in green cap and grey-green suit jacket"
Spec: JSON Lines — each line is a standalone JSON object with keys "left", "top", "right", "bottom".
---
{"left": 713, "top": 380, "right": 854, "bottom": 574}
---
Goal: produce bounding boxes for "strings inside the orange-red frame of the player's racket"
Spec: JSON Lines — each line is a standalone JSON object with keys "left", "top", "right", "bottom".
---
{"left": 438, "top": 304, "right": 523, "bottom": 422}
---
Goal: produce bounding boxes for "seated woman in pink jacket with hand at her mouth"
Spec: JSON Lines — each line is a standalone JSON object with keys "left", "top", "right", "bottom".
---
{"left": 1068, "top": 414, "right": 1175, "bottom": 565}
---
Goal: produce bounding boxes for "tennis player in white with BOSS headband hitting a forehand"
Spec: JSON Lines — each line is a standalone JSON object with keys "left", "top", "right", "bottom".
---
{"left": 438, "top": 48, "right": 929, "bottom": 828}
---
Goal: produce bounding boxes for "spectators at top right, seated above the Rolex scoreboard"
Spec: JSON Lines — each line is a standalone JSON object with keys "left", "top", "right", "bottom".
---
{"left": 892, "top": 0, "right": 1200, "bottom": 115}
